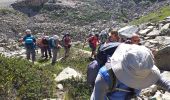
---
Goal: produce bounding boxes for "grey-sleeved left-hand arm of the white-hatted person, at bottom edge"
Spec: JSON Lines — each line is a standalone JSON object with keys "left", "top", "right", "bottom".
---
{"left": 90, "top": 74, "right": 109, "bottom": 100}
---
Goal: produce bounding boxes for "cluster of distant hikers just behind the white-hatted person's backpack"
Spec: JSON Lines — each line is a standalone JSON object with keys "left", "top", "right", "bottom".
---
{"left": 85, "top": 29, "right": 140, "bottom": 59}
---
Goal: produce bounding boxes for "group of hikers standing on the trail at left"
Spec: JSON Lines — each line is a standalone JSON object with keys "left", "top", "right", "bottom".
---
{"left": 21, "top": 29, "right": 71, "bottom": 65}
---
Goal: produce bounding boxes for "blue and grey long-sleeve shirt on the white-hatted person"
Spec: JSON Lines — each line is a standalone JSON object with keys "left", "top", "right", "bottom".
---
{"left": 90, "top": 69, "right": 170, "bottom": 100}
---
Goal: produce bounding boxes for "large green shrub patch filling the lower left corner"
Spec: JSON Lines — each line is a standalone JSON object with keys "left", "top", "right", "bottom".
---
{"left": 0, "top": 54, "right": 55, "bottom": 100}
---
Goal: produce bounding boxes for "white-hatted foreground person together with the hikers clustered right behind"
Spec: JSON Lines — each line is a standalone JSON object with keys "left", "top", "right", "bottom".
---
{"left": 86, "top": 30, "right": 170, "bottom": 100}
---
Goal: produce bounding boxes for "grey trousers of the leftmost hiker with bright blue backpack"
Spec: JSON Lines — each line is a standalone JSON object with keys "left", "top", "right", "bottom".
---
{"left": 26, "top": 48, "right": 36, "bottom": 62}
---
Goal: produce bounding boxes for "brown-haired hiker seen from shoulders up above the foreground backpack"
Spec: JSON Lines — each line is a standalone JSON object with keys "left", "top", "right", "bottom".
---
{"left": 106, "top": 30, "right": 120, "bottom": 43}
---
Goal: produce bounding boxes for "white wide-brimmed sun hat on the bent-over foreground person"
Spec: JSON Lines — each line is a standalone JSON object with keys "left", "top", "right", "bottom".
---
{"left": 111, "top": 44, "right": 160, "bottom": 89}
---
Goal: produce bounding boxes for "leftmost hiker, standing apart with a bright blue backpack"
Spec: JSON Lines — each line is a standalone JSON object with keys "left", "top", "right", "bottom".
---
{"left": 23, "top": 29, "right": 36, "bottom": 64}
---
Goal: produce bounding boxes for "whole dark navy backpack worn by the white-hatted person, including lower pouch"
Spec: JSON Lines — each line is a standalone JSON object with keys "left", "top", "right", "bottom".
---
{"left": 87, "top": 42, "right": 120, "bottom": 86}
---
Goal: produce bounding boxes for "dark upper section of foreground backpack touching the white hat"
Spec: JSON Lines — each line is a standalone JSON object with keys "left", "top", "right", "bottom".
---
{"left": 96, "top": 42, "right": 121, "bottom": 67}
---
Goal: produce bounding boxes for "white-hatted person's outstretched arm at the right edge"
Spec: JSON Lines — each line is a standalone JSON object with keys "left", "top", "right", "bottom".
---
{"left": 156, "top": 77, "right": 170, "bottom": 92}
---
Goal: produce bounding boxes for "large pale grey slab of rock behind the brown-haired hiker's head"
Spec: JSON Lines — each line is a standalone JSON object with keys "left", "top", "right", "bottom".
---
{"left": 118, "top": 25, "right": 139, "bottom": 38}
